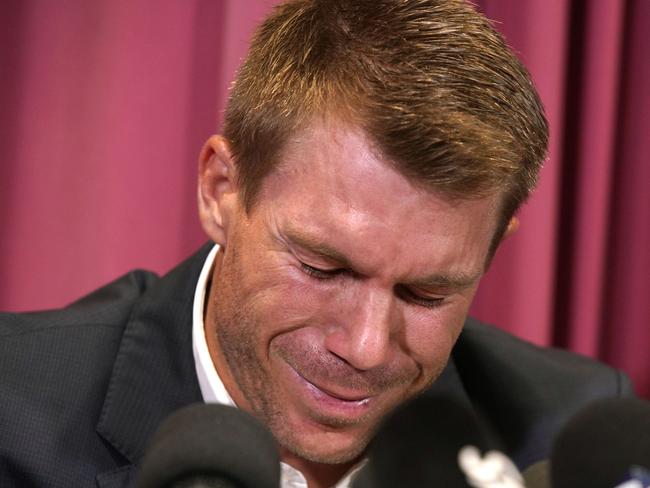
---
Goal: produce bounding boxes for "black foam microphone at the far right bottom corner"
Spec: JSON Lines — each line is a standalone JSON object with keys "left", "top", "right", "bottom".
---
{"left": 551, "top": 398, "right": 650, "bottom": 488}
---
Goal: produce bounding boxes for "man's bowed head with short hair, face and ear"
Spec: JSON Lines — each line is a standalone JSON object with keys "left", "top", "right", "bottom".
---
{"left": 199, "top": 0, "right": 546, "bottom": 480}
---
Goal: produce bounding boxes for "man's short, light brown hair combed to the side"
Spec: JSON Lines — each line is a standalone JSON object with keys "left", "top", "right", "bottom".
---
{"left": 224, "top": 0, "right": 548, "bottom": 236}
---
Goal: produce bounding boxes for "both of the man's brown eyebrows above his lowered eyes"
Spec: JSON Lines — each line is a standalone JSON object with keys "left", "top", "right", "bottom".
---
{"left": 285, "top": 228, "right": 483, "bottom": 289}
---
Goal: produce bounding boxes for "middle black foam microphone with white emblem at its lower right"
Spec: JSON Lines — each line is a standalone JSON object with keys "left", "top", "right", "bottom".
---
{"left": 352, "top": 396, "right": 523, "bottom": 488}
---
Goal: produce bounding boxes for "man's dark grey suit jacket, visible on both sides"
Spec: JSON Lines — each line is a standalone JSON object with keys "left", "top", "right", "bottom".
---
{"left": 0, "top": 245, "right": 631, "bottom": 488}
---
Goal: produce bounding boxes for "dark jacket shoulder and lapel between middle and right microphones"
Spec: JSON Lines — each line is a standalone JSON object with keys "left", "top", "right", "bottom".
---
{"left": 452, "top": 319, "right": 633, "bottom": 466}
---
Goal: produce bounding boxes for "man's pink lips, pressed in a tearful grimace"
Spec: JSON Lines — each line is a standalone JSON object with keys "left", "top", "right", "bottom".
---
{"left": 287, "top": 364, "right": 374, "bottom": 421}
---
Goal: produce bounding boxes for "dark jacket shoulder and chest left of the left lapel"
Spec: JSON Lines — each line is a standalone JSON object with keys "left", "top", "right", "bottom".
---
{"left": 0, "top": 271, "right": 157, "bottom": 486}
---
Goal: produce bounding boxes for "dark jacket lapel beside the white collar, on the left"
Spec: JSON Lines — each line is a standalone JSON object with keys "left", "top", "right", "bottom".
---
{"left": 97, "top": 244, "right": 212, "bottom": 487}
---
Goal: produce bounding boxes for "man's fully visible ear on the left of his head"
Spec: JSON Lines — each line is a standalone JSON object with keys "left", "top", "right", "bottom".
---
{"left": 198, "top": 135, "right": 239, "bottom": 247}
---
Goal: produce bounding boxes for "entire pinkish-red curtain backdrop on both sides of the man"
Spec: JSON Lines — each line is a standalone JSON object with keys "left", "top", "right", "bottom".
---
{"left": 0, "top": 0, "right": 650, "bottom": 397}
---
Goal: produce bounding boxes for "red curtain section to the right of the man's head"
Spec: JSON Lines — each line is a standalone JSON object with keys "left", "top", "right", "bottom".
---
{"left": 473, "top": 0, "right": 650, "bottom": 397}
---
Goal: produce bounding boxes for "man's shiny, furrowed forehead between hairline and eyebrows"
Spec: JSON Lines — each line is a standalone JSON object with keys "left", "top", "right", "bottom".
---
{"left": 252, "top": 118, "right": 498, "bottom": 271}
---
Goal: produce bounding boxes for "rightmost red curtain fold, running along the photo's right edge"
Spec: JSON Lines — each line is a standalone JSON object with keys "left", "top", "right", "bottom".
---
{"left": 598, "top": 0, "right": 650, "bottom": 397}
